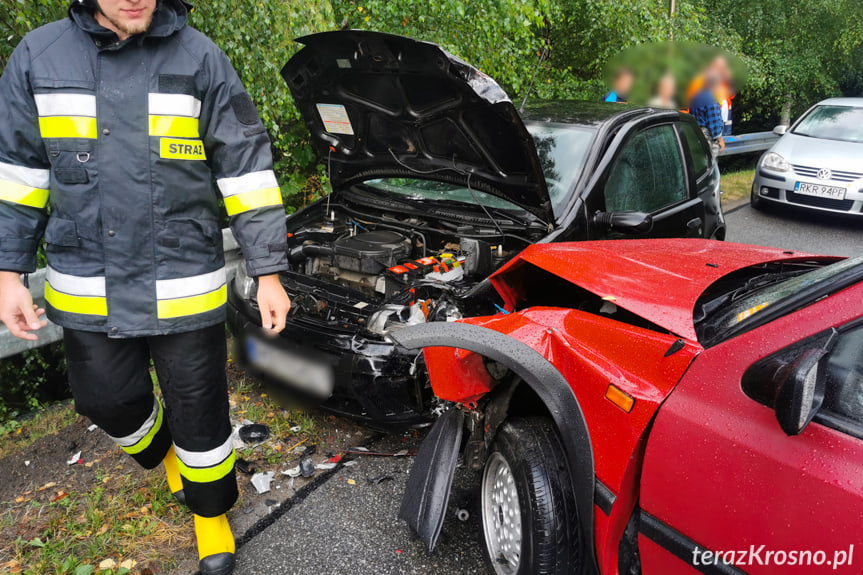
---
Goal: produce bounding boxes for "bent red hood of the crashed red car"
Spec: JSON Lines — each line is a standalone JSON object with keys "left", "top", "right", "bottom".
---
{"left": 491, "top": 239, "right": 824, "bottom": 341}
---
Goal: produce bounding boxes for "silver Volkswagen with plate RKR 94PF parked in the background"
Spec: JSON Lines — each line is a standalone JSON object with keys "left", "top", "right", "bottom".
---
{"left": 750, "top": 98, "right": 863, "bottom": 215}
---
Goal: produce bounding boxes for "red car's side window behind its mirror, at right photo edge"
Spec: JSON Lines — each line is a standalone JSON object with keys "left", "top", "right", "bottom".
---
{"left": 821, "top": 325, "right": 863, "bottom": 430}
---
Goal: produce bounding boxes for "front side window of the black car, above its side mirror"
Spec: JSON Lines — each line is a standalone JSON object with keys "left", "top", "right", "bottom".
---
{"left": 605, "top": 126, "right": 686, "bottom": 213}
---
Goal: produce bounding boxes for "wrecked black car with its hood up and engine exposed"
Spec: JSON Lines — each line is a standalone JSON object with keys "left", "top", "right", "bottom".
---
{"left": 228, "top": 31, "right": 725, "bottom": 427}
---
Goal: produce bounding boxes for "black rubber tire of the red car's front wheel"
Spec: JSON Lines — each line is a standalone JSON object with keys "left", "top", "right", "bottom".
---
{"left": 480, "top": 417, "right": 584, "bottom": 575}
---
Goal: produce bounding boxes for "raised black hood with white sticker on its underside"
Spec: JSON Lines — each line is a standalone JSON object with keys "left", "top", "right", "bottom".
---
{"left": 282, "top": 30, "right": 553, "bottom": 222}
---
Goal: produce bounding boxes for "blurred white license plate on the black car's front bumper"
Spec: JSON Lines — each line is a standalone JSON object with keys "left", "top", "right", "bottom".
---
{"left": 246, "top": 338, "right": 334, "bottom": 399}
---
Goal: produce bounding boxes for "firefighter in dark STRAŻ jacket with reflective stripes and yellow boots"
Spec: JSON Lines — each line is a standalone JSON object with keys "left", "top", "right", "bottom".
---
{"left": 0, "top": 0, "right": 290, "bottom": 575}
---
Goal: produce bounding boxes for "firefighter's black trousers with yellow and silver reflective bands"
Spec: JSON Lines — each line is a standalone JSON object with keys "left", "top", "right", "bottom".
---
{"left": 64, "top": 324, "right": 238, "bottom": 517}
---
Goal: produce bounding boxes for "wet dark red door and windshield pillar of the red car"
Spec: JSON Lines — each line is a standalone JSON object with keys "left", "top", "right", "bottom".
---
{"left": 641, "top": 284, "right": 863, "bottom": 575}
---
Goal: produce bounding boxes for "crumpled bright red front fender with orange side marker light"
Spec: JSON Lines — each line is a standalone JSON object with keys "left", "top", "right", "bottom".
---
{"left": 424, "top": 308, "right": 701, "bottom": 569}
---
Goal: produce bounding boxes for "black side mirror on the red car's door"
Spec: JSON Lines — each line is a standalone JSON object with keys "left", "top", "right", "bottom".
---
{"left": 773, "top": 349, "right": 826, "bottom": 436}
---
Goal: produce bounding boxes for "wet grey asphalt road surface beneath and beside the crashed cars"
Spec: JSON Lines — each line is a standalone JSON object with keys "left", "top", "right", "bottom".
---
{"left": 236, "top": 199, "right": 863, "bottom": 575}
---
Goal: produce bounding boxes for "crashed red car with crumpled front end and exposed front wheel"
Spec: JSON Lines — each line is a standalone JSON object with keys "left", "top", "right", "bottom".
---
{"left": 392, "top": 240, "right": 863, "bottom": 575}
